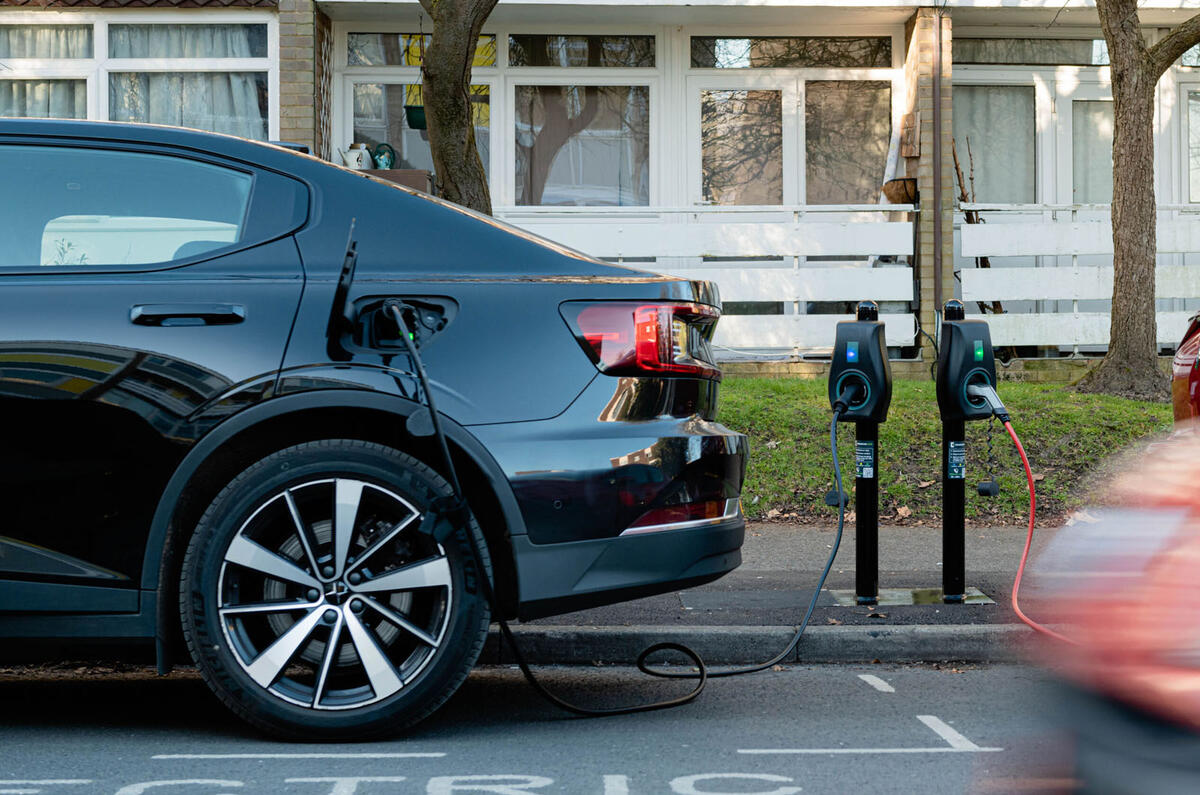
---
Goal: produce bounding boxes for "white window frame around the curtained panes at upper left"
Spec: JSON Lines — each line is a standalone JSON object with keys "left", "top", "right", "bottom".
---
{"left": 0, "top": 8, "right": 280, "bottom": 139}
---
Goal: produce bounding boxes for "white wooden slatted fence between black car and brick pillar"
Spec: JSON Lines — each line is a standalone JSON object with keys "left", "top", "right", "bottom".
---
{"left": 496, "top": 205, "right": 916, "bottom": 358}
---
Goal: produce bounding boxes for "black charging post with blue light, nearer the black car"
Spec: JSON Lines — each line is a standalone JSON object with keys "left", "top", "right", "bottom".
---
{"left": 829, "top": 301, "right": 892, "bottom": 604}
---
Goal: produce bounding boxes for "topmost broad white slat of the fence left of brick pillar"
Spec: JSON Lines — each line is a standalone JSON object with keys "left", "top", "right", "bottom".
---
{"left": 521, "top": 220, "right": 912, "bottom": 257}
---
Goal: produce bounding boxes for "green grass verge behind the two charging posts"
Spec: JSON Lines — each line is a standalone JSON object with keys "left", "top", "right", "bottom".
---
{"left": 719, "top": 377, "right": 1171, "bottom": 525}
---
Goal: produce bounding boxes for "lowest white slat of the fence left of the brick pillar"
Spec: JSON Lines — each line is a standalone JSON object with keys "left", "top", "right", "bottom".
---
{"left": 714, "top": 315, "right": 917, "bottom": 349}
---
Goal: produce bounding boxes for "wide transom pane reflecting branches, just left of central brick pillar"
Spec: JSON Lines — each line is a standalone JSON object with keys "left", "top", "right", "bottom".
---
{"left": 691, "top": 36, "right": 892, "bottom": 68}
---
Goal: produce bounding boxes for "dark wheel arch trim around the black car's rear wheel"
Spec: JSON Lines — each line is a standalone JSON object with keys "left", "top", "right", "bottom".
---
{"left": 142, "top": 389, "right": 526, "bottom": 671}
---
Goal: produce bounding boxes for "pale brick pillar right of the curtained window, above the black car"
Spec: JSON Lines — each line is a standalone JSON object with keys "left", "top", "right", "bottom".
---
{"left": 280, "top": 0, "right": 319, "bottom": 153}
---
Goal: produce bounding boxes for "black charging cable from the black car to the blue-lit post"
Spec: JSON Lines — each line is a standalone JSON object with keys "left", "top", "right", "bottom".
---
{"left": 384, "top": 299, "right": 862, "bottom": 717}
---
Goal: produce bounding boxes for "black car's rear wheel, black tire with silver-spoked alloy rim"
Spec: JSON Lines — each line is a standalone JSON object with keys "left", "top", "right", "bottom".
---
{"left": 180, "top": 440, "right": 491, "bottom": 741}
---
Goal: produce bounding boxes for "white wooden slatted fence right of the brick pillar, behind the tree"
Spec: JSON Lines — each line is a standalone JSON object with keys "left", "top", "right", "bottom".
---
{"left": 959, "top": 204, "right": 1200, "bottom": 347}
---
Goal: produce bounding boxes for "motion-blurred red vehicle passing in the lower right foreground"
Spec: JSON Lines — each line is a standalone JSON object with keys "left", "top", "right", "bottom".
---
{"left": 1026, "top": 437, "right": 1200, "bottom": 795}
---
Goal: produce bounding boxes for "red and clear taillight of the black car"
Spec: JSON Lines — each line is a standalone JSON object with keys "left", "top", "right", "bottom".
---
{"left": 563, "top": 301, "right": 721, "bottom": 381}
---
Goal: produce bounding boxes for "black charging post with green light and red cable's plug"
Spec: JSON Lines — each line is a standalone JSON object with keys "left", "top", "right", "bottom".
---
{"left": 937, "top": 299, "right": 996, "bottom": 603}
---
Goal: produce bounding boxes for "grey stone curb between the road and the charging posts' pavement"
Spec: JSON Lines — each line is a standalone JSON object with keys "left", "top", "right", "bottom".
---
{"left": 479, "top": 623, "right": 1032, "bottom": 665}
